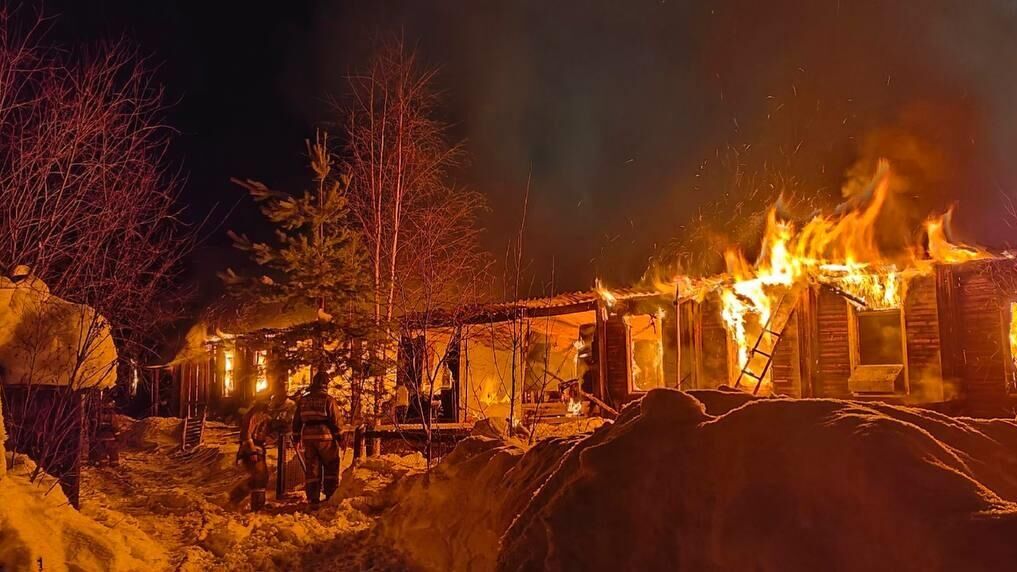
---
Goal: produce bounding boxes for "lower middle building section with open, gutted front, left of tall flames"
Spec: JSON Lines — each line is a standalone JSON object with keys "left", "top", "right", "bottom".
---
{"left": 398, "top": 289, "right": 679, "bottom": 422}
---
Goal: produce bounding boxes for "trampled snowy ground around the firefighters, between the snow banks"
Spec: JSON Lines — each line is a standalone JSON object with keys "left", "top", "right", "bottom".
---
{"left": 81, "top": 418, "right": 424, "bottom": 571}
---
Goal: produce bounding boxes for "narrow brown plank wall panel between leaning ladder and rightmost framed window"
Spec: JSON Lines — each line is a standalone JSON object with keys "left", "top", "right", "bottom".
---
{"left": 813, "top": 288, "right": 851, "bottom": 398}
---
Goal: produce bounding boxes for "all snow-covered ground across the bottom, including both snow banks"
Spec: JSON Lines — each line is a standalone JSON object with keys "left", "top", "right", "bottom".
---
{"left": 7, "top": 390, "right": 1017, "bottom": 572}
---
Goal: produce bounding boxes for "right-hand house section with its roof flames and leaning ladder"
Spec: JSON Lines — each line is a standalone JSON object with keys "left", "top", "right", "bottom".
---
{"left": 634, "top": 165, "right": 1017, "bottom": 416}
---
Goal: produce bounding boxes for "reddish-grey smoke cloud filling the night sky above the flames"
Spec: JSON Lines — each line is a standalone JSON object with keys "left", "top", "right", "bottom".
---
{"left": 303, "top": 0, "right": 1017, "bottom": 290}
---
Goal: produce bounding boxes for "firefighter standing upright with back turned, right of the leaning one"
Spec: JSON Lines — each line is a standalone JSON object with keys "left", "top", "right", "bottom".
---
{"left": 293, "top": 371, "right": 341, "bottom": 507}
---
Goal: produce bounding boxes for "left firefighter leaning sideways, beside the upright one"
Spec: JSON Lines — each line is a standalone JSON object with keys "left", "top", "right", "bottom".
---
{"left": 233, "top": 383, "right": 293, "bottom": 511}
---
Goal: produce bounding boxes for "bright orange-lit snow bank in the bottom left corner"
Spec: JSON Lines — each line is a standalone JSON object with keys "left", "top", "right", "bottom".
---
{"left": 0, "top": 456, "right": 166, "bottom": 572}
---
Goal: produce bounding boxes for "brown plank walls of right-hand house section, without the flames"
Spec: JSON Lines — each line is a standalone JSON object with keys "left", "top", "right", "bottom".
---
{"left": 678, "top": 259, "right": 1017, "bottom": 416}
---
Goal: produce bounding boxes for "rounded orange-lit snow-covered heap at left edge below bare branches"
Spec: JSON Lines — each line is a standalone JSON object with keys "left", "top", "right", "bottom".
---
{"left": 0, "top": 276, "right": 117, "bottom": 390}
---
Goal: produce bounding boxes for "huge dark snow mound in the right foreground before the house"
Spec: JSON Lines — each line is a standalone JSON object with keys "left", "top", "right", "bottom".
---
{"left": 382, "top": 390, "right": 1017, "bottom": 571}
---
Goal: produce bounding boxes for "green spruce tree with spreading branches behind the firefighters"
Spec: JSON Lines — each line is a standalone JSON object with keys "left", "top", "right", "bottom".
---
{"left": 222, "top": 134, "right": 366, "bottom": 374}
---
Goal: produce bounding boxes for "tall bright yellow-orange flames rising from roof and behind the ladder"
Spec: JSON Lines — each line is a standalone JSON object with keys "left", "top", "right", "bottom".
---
{"left": 596, "top": 161, "right": 992, "bottom": 394}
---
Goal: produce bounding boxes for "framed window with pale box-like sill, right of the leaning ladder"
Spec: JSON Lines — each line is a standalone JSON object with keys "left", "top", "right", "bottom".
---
{"left": 845, "top": 302, "right": 907, "bottom": 394}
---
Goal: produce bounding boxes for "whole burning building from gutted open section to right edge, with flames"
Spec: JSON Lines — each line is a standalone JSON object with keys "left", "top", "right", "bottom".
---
{"left": 403, "top": 165, "right": 1017, "bottom": 418}
